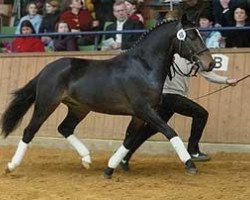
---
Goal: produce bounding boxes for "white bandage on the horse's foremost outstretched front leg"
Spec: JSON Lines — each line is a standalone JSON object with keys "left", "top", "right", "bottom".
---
{"left": 170, "top": 136, "right": 191, "bottom": 163}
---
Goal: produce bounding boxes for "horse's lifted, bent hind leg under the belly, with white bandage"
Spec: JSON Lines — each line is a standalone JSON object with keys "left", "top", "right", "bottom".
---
{"left": 58, "top": 107, "right": 91, "bottom": 169}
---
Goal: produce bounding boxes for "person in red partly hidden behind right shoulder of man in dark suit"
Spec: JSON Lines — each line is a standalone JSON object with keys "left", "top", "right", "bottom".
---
{"left": 125, "top": 0, "right": 144, "bottom": 24}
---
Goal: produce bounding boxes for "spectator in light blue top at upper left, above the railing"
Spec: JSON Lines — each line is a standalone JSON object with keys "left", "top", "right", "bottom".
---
{"left": 15, "top": 2, "right": 42, "bottom": 34}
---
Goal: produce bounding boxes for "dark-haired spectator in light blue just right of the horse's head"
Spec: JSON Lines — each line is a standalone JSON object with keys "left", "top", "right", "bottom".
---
{"left": 199, "top": 13, "right": 225, "bottom": 48}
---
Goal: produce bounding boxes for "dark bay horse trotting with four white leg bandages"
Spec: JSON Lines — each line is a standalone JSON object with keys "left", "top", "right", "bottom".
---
{"left": 2, "top": 17, "right": 214, "bottom": 178}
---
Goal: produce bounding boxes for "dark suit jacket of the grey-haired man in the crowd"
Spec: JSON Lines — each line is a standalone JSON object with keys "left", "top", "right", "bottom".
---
{"left": 105, "top": 19, "right": 144, "bottom": 50}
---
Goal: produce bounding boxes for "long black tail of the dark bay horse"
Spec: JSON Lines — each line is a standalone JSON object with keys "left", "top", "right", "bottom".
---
{"left": 1, "top": 77, "right": 38, "bottom": 138}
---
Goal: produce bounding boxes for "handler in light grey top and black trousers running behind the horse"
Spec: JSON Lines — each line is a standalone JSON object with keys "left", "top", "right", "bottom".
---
{"left": 120, "top": 54, "right": 238, "bottom": 171}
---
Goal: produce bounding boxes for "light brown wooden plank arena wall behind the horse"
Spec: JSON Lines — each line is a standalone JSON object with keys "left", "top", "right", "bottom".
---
{"left": 0, "top": 49, "right": 250, "bottom": 144}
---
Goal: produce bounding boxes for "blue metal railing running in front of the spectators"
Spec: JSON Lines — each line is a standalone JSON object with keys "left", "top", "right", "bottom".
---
{"left": 0, "top": 26, "right": 250, "bottom": 50}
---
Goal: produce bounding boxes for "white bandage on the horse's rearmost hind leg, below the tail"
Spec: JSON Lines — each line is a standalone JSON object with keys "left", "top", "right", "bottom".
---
{"left": 8, "top": 140, "right": 28, "bottom": 172}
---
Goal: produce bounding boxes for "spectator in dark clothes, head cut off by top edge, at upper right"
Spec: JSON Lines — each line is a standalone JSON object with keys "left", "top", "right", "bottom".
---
{"left": 213, "top": 0, "right": 239, "bottom": 27}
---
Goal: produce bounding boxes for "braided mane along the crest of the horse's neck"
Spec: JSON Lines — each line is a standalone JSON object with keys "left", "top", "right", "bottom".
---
{"left": 121, "top": 19, "right": 178, "bottom": 54}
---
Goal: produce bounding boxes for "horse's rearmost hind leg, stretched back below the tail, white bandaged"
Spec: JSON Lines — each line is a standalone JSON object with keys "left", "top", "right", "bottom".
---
{"left": 6, "top": 101, "right": 59, "bottom": 172}
